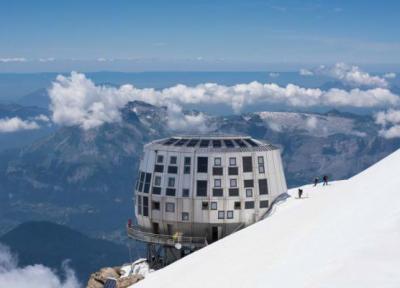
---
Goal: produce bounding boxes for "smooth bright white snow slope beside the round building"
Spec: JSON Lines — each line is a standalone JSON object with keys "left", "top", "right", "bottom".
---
{"left": 134, "top": 150, "right": 400, "bottom": 288}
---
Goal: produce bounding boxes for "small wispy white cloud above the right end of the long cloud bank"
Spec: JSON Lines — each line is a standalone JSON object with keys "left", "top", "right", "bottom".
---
{"left": 314, "top": 63, "right": 388, "bottom": 88}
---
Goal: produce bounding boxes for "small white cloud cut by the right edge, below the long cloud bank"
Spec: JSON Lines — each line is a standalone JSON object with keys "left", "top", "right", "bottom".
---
{"left": 375, "top": 109, "right": 400, "bottom": 139}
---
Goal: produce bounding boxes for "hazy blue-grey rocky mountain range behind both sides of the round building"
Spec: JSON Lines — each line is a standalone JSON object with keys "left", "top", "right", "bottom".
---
{"left": 0, "top": 102, "right": 400, "bottom": 241}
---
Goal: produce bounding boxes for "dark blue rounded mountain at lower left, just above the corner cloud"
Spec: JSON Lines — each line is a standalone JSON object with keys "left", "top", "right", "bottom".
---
{"left": 0, "top": 222, "right": 138, "bottom": 283}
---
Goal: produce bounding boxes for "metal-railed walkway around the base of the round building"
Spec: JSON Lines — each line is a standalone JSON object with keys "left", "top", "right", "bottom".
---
{"left": 127, "top": 226, "right": 208, "bottom": 247}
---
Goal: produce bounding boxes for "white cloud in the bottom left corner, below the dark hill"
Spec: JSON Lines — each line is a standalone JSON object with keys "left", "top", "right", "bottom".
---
{"left": 0, "top": 244, "right": 81, "bottom": 288}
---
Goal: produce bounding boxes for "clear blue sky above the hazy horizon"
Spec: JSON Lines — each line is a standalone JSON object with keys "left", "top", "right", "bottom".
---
{"left": 0, "top": 0, "right": 400, "bottom": 72}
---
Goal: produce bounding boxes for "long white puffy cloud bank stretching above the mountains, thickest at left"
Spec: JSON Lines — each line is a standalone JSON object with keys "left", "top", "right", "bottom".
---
{"left": 49, "top": 72, "right": 400, "bottom": 130}
